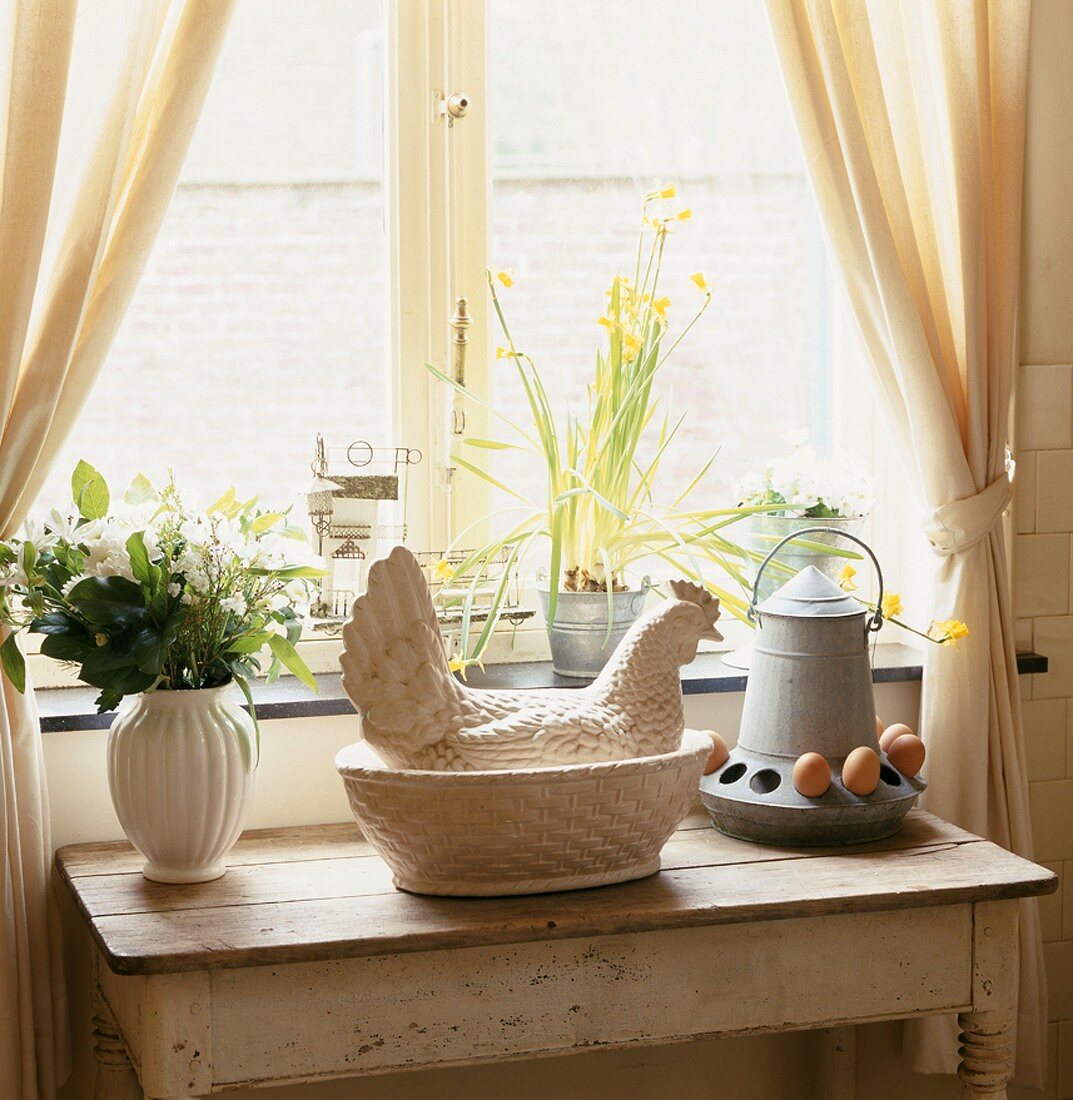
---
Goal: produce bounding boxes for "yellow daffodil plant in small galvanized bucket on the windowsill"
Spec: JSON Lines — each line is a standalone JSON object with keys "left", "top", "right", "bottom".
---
{"left": 426, "top": 186, "right": 770, "bottom": 677}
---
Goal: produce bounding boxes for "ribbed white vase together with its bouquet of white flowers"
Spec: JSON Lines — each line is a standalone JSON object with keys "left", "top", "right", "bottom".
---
{"left": 0, "top": 462, "right": 324, "bottom": 882}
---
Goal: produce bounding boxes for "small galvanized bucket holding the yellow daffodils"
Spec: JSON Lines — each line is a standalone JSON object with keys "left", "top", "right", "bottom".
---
{"left": 538, "top": 578, "right": 652, "bottom": 680}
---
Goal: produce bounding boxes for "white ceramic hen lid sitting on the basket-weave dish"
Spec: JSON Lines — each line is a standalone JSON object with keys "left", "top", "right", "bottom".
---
{"left": 340, "top": 547, "right": 722, "bottom": 771}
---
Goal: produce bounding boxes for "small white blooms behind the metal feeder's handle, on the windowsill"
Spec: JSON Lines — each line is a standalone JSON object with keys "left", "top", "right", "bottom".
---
{"left": 736, "top": 447, "right": 874, "bottom": 519}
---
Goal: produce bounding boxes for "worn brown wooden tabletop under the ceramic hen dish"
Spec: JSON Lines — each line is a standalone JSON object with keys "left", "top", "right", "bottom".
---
{"left": 56, "top": 811, "right": 1058, "bottom": 975}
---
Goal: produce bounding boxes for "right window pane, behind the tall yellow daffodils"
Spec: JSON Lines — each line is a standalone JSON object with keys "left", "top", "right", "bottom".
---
{"left": 489, "top": 0, "right": 830, "bottom": 514}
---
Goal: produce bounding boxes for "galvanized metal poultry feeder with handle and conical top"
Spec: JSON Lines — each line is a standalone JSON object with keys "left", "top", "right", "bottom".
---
{"left": 700, "top": 527, "right": 927, "bottom": 847}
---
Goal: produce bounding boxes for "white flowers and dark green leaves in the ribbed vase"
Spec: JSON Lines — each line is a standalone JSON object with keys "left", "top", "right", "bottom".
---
{"left": 0, "top": 462, "right": 325, "bottom": 712}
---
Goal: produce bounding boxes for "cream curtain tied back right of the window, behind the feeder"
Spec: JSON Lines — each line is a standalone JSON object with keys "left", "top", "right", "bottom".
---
{"left": 768, "top": 0, "right": 1047, "bottom": 1087}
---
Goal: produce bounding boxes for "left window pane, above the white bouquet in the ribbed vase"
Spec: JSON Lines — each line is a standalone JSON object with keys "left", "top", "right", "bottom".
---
{"left": 43, "top": 0, "right": 391, "bottom": 504}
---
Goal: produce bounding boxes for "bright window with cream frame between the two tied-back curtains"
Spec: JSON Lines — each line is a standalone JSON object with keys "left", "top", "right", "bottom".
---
{"left": 43, "top": 0, "right": 908, "bottom": 660}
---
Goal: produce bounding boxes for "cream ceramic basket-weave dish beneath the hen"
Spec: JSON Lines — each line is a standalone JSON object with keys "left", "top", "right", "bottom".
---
{"left": 336, "top": 729, "right": 712, "bottom": 897}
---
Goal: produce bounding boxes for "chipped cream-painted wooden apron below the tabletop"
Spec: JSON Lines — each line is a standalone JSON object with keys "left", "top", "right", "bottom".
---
{"left": 100, "top": 903, "right": 981, "bottom": 1097}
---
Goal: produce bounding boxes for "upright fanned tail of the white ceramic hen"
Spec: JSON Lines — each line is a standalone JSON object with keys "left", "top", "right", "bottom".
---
{"left": 339, "top": 547, "right": 462, "bottom": 768}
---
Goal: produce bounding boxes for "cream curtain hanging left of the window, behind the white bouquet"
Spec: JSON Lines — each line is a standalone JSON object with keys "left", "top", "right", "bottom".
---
{"left": 0, "top": 0, "right": 233, "bottom": 1100}
